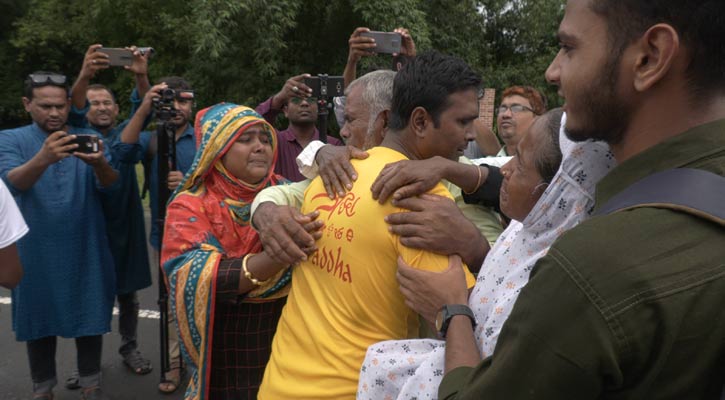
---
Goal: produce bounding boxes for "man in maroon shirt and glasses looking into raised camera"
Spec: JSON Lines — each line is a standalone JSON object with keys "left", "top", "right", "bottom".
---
{"left": 256, "top": 74, "right": 342, "bottom": 182}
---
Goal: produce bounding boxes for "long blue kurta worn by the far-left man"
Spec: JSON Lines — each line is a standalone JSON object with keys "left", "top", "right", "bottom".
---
{"left": 0, "top": 124, "right": 117, "bottom": 341}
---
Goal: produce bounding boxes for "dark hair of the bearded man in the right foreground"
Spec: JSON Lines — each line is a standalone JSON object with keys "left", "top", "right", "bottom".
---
{"left": 591, "top": 0, "right": 725, "bottom": 101}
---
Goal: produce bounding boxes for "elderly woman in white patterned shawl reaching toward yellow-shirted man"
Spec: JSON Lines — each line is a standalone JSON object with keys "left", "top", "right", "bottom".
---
{"left": 357, "top": 110, "right": 614, "bottom": 400}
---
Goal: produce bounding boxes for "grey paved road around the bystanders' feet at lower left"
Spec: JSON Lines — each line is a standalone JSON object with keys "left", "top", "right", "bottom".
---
{"left": 0, "top": 211, "right": 185, "bottom": 400}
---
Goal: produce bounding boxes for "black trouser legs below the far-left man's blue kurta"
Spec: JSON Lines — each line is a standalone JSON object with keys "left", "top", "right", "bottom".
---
{"left": 27, "top": 335, "right": 103, "bottom": 384}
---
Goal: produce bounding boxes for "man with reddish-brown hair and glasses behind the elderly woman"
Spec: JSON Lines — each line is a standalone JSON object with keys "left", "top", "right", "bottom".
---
{"left": 496, "top": 86, "right": 546, "bottom": 157}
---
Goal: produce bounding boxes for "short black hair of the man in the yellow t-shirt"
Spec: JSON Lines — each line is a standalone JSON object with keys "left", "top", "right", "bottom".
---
{"left": 390, "top": 51, "right": 481, "bottom": 130}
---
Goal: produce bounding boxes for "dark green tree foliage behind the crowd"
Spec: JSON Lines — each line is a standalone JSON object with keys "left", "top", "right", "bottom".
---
{"left": 0, "top": 0, "right": 564, "bottom": 128}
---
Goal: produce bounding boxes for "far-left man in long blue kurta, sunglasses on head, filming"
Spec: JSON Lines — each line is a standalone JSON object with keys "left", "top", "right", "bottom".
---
{"left": 0, "top": 72, "right": 118, "bottom": 399}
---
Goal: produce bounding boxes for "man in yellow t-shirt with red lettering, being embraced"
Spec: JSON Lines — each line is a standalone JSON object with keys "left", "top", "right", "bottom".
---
{"left": 259, "top": 53, "right": 480, "bottom": 400}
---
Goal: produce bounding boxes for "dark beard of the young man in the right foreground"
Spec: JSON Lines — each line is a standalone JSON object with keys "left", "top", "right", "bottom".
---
{"left": 564, "top": 54, "right": 632, "bottom": 145}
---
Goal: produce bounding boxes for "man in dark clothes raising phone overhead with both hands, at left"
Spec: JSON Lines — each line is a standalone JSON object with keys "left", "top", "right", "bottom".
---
{"left": 66, "top": 44, "right": 156, "bottom": 382}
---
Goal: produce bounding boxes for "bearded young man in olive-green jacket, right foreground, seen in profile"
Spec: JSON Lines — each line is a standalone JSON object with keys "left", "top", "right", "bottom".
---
{"left": 399, "top": 0, "right": 725, "bottom": 399}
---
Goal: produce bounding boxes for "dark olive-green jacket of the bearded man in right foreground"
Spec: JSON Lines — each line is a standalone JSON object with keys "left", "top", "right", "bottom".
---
{"left": 439, "top": 120, "right": 725, "bottom": 400}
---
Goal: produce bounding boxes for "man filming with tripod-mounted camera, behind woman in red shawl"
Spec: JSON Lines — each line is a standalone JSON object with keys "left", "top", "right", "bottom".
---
{"left": 113, "top": 76, "right": 196, "bottom": 393}
